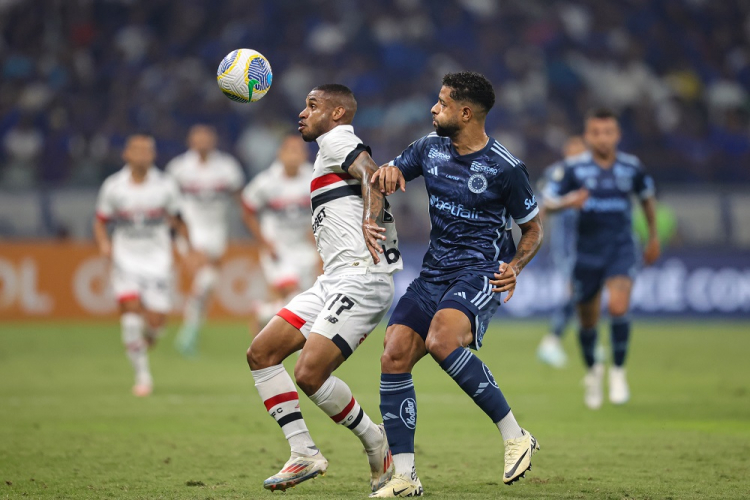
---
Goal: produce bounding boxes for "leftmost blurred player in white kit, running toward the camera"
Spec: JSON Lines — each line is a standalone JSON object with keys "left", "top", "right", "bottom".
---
{"left": 94, "top": 135, "right": 189, "bottom": 396}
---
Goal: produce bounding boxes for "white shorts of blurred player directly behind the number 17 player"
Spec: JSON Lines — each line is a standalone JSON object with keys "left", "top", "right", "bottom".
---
{"left": 260, "top": 244, "right": 320, "bottom": 289}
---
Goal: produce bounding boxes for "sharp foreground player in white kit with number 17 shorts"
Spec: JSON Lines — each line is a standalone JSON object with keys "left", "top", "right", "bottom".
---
{"left": 247, "top": 84, "right": 402, "bottom": 491}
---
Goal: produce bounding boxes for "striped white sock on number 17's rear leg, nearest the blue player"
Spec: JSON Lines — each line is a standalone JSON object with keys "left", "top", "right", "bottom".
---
{"left": 310, "top": 377, "right": 383, "bottom": 451}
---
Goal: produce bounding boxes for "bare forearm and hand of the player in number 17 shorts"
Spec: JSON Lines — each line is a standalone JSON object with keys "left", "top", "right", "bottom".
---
{"left": 348, "top": 151, "right": 385, "bottom": 264}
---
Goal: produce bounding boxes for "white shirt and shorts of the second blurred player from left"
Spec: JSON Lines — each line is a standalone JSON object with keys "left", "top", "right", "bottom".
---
{"left": 166, "top": 150, "right": 245, "bottom": 257}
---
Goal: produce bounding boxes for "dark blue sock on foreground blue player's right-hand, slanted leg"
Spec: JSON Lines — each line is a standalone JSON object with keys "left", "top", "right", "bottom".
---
{"left": 440, "top": 347, "right": 510, "bottom": 422}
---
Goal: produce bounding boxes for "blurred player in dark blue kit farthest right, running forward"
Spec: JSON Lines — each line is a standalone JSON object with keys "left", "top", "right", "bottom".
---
{"left": 545, "top": 109, "right": 660, "bottom": 409}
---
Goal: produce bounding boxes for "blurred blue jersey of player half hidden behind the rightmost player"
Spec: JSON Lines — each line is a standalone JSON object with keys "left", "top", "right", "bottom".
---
{"left": 537, "top": 161, "right": 578, "bottom": 273}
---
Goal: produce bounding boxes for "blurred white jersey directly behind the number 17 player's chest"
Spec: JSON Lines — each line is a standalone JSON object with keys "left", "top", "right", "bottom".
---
{"left": 242, "top": 161, "right": 313, "bottom": 248}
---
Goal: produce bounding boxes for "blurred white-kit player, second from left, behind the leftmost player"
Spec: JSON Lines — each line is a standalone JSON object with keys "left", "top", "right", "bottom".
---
{"left": 167, "top": 125, "right": 245, "bottom": 356}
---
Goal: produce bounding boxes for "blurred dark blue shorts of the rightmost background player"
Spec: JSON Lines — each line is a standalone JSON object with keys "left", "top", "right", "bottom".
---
{"left": 573, "top": 243, "right": 640, "bottom": 304}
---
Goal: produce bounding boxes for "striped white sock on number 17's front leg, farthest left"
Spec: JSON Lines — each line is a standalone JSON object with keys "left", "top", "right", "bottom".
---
{"left": 252, "top": 365, "right": 318, "bottom": 456}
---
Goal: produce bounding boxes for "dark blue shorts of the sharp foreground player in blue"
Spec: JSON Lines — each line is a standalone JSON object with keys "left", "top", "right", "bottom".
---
{"left": 388, "top": 270, "right": 500, "bottom": 349}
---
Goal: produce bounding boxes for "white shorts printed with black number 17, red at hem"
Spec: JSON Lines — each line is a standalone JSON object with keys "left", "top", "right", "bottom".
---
{"left": 277, "top": 273, "right": 393, "bottom": 358}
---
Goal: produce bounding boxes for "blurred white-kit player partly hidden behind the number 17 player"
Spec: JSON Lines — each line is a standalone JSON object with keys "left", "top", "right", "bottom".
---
{"left": 242, "top": 135, "right": 322, "bottom": 333}
